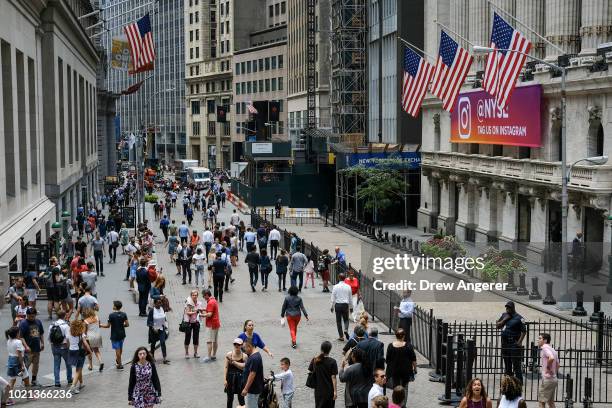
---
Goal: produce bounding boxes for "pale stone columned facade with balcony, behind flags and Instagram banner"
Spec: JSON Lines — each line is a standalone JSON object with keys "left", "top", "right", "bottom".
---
{"left": 419, "top": 0, "right": 612, "bottom": 273}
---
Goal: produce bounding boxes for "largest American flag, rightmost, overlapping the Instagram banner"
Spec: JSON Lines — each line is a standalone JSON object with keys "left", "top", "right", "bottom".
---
{"left": 484, "top": 13, "right": 531, "bottom": 108}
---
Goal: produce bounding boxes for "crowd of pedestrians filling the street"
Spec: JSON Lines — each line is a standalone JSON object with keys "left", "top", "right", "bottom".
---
{"left": 0, "top": 173, "right": 558, "bottom": 408}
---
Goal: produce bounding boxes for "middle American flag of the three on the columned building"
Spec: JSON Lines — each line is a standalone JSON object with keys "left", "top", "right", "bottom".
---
{"left": 431, "top": 31, "right": 474, "bottom": 112}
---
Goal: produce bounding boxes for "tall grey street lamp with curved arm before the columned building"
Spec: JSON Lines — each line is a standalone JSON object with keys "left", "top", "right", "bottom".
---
{"left": 472, "top": 45, "right": 571, "bottom": 309}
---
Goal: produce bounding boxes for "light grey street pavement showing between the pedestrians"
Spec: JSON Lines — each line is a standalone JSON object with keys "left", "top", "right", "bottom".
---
{"left": 0, "top": 193, "right": 452, "bottom": 408}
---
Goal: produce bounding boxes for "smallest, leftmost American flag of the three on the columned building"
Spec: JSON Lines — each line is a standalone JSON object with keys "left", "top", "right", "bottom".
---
{"left": 402, "top": 48, "right": 433, "bottom": 118}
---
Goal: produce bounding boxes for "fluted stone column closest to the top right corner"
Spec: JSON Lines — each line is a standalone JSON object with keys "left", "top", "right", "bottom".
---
{"left": 580, "top": 0, "right": 612, "bottom": 55}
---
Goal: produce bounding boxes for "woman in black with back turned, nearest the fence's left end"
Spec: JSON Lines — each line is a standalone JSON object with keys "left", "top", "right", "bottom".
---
{"left": 385, "top": 328, "right": 417, "bottom": 405}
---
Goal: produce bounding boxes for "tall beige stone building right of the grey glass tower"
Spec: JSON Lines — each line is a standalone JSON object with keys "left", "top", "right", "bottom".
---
{"left": 184, "top": 0, "right": 266, "bottom": 169}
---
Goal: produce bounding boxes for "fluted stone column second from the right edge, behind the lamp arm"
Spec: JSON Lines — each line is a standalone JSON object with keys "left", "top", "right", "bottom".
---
{"left": 546, "top": 0, "right": 580, "bottom": 59}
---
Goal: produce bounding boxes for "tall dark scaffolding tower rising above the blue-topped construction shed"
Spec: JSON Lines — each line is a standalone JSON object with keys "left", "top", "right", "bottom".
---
{"left": 331, "top": 0, "right": 367, "bottom": 144}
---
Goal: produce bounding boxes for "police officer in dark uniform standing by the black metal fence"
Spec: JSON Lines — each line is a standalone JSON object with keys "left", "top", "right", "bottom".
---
{"left": 497, "top": 302, "right": 527, "bottom": 383}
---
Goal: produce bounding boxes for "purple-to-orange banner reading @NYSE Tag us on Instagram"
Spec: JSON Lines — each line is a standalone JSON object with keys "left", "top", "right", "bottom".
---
{"left": 451, "top": 85, "right": 542, "bottom": 147}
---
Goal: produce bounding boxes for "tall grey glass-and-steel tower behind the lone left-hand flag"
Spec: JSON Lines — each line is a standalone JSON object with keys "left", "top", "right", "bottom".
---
{"left": 99, "top": 0, "right": 184, "bottom": 164}
